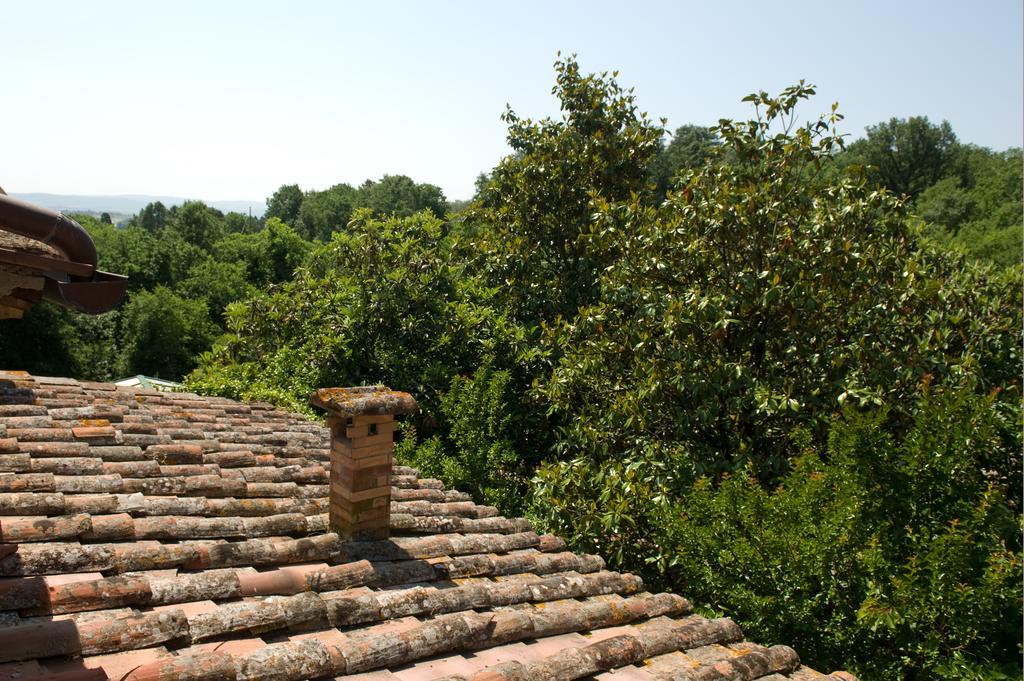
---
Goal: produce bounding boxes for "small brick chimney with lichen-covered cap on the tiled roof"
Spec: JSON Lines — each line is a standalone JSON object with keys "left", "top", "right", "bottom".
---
{"left": 309, "top": 385, "right": 418, "bottom": 541}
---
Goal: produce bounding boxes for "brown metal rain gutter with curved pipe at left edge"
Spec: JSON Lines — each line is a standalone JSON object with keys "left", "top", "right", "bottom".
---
{"left": 0, "top": 193, "right": 128, "bottom": 314}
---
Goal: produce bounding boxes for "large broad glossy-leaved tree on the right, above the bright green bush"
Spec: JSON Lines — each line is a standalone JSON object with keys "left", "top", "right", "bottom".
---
{"left": 537, "top": 80, "right": 1022, "bottom": 571}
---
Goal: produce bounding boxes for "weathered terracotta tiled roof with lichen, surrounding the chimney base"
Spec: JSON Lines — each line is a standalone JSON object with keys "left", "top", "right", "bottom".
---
{"left": 0, "top": 372, "right": 852, "bottom": 681}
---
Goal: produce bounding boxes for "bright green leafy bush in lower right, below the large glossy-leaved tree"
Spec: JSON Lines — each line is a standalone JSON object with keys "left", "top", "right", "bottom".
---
{"left": 658, "top": 391, "right": 1022, "bottom": 679}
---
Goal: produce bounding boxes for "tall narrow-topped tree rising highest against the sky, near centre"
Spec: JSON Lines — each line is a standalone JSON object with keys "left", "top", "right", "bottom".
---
{"left": 475, "top": 58, "right": 663, "bottom": 324}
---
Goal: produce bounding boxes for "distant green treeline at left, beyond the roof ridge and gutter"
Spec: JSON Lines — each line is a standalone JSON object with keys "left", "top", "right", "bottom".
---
{"left": 0, "top": 175, "right": 449, "bottom": 380}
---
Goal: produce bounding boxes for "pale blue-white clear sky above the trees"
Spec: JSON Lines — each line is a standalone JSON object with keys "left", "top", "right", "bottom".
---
{"left": 0, "top": 0, "right": 1024, "bottom": 201}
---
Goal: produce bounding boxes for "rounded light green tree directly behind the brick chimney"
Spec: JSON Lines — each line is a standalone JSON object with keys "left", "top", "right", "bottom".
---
{"left": 189, "top": 210, "right": 510, "bottom": 413}
